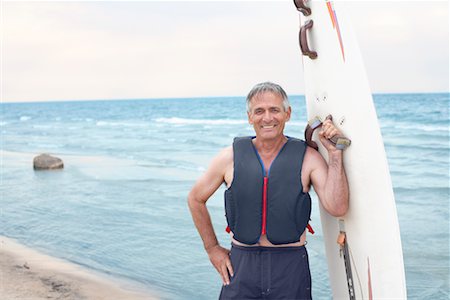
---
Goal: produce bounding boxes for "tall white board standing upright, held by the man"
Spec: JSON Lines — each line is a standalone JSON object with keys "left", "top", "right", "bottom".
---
{"left": 294, "top": 0, "right": 406, "bottom": 299}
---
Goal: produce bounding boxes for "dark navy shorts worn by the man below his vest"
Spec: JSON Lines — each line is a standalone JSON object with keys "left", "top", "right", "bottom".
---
{"left": 219, "top": 244, "right": 311, "bottom": 299}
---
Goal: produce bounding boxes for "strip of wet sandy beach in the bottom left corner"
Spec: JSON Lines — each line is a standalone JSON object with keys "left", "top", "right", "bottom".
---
{"left": 0, "top": 236, "right": 158, "bottom": 300}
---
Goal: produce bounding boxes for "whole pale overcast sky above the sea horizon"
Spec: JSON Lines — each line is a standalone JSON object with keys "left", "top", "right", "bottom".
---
{"left": 0, "top": 0, "right": 449, "bottom": 102}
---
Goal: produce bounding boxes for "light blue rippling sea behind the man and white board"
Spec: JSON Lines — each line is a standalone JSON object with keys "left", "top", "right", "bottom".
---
{"left": 0, "top": 93, "right": 450, "bottom": 299}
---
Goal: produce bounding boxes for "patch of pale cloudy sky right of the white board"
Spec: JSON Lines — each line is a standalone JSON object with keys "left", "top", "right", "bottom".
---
{"left": 349, "top": 1, "right": 449, "bottom": 92}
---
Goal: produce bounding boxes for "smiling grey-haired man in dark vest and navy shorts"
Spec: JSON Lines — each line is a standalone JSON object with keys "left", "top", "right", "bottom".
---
{"left": 188, "top": 82, "right": 348, "bottom": 299}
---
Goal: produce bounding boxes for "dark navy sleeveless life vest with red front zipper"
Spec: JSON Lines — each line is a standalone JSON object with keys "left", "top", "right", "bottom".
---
{"left": 225, "top": 137, "right": 311, "bottom": 245}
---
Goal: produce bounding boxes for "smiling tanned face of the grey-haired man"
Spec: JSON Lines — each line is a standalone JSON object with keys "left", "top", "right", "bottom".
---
{"left": 247, "top": 92, "right": 291, "bottom": 140}
